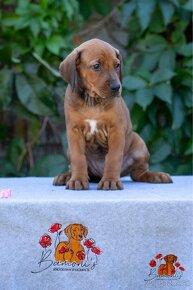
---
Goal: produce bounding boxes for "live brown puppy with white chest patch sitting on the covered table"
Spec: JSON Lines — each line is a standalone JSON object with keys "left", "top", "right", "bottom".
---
{"left": 54, "top": 39, "right": 172, "bottom": 190}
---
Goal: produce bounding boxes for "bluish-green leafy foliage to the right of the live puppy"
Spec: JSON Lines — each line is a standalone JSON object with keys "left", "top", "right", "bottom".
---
{"left": 122, "top": 0, "right": 192, "bottom": 174}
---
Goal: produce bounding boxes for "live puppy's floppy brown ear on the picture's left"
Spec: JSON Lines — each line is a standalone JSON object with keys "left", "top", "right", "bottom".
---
{"left": 59, "top": 49, "right": 80, "bottom": 91}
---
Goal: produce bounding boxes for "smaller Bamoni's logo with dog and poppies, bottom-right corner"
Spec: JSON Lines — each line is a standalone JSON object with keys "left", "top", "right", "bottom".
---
{"left": 145, "top": 254, "right": 185, "bottom": 281}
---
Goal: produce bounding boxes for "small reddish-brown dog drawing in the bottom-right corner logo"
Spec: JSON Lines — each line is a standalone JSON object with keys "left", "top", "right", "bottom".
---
{"left": 158, "top": 254, "right": 178, "bottom": 276}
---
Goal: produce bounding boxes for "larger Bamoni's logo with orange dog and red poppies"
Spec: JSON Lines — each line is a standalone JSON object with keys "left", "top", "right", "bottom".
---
{"left": 31, "top": 223, "right": 101, "bottom": 273}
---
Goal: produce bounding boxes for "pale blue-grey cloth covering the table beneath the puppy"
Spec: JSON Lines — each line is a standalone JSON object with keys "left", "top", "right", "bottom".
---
{"left": 0, "top": 176, "right": 193, "bottom": 290}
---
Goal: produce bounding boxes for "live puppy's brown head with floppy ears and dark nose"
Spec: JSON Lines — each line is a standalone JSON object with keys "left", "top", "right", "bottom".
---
{"left": 60, "top": 39, "right": 122, "bottom": 98}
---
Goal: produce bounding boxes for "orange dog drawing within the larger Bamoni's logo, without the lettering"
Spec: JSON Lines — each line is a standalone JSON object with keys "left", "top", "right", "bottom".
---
{"left": 55, "top": 224, "right": 88, "bottom": 264}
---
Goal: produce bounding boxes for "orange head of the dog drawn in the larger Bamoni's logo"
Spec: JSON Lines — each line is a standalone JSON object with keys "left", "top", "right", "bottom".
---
{"left": 65, "top": 224, "right": 88, "bottom": 241}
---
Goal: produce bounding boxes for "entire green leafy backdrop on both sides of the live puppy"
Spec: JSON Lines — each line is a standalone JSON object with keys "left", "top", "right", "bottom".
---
{"left": 0, "top": 0, "right": 192, "bottom": 176}
